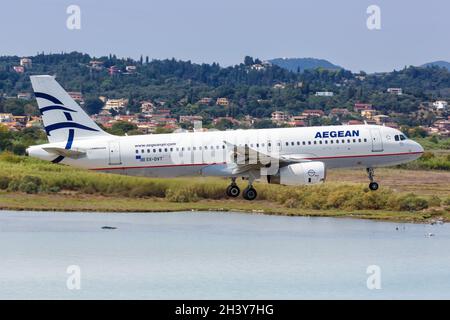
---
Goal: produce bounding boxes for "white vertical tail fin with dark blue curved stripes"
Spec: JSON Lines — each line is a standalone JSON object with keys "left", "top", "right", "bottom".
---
{"left": 30, "top": 75, "right": 109, "bottom": 143}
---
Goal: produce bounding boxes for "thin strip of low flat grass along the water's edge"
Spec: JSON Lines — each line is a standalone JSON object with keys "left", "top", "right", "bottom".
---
{"left": 0, "top": 193, "right": 450, "bottom": 224}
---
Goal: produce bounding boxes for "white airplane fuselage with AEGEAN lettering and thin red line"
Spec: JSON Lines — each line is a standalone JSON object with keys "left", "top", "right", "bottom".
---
{"left": 28, "top": 125, "right": 423, "bottom": 177}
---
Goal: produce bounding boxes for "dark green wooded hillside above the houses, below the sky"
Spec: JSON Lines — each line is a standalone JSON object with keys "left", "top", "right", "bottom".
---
{"left": 0, "top": 52, "right": 450, "bottom": 126}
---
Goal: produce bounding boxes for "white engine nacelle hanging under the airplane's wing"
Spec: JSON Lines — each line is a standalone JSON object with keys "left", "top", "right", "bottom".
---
{"left": 267, "top": 161, "right": 326, "bottom": 186}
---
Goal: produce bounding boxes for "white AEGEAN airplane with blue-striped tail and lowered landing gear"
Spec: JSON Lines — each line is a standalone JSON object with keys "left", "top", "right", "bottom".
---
{"left": 27, "top": 75, "right": 424, "bottom": 200}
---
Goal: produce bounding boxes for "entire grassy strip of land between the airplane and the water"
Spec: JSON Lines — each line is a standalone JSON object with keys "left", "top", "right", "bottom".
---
{"left": 0, "top": 153, "right": 450, "bottom": 222}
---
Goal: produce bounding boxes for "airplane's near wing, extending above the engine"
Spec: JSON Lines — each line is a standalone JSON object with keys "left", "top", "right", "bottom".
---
{"left": 224, "top": 141, "right": 314, "bottom": 174}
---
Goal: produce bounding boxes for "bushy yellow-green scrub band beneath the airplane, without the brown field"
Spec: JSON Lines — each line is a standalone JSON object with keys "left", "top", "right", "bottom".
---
{"left": 0, "top": 153, "right": 450, "bottom": 218}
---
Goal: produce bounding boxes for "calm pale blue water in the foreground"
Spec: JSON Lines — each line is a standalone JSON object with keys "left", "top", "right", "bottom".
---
{"left": 0, "top": 211, "right": 450, "bottom": 299}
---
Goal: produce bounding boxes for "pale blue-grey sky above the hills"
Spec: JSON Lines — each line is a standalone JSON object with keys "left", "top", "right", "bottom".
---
{"left": 0, "top": 0, "right": 450, "bottom": 72}
